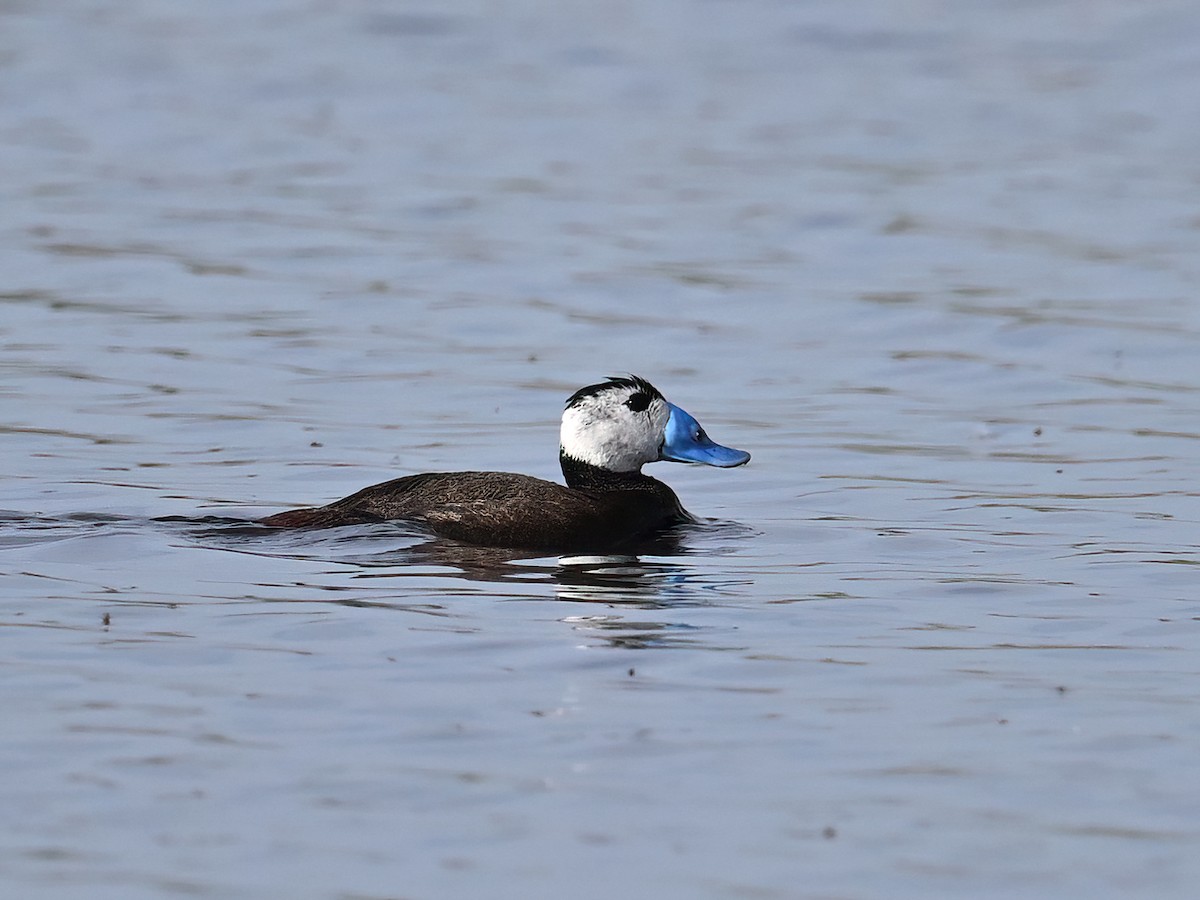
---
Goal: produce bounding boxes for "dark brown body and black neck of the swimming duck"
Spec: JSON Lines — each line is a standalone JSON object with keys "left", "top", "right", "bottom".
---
{"left": 262, "top": 457, "right": 692, "bottom": 552}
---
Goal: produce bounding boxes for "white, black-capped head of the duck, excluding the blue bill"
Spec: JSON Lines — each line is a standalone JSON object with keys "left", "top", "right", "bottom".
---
{"left": 559, "top": 384, "right": 671, "bottom": 472}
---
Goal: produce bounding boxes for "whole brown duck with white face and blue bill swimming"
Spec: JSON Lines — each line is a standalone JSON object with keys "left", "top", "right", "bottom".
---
{"left": 259, "top": 374, "right": 750, "bottom": 552}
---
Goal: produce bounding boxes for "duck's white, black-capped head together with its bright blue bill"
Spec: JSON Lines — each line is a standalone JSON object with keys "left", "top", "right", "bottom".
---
{"left": 559, "top": 376, "right": 750, "bottom": 472}
